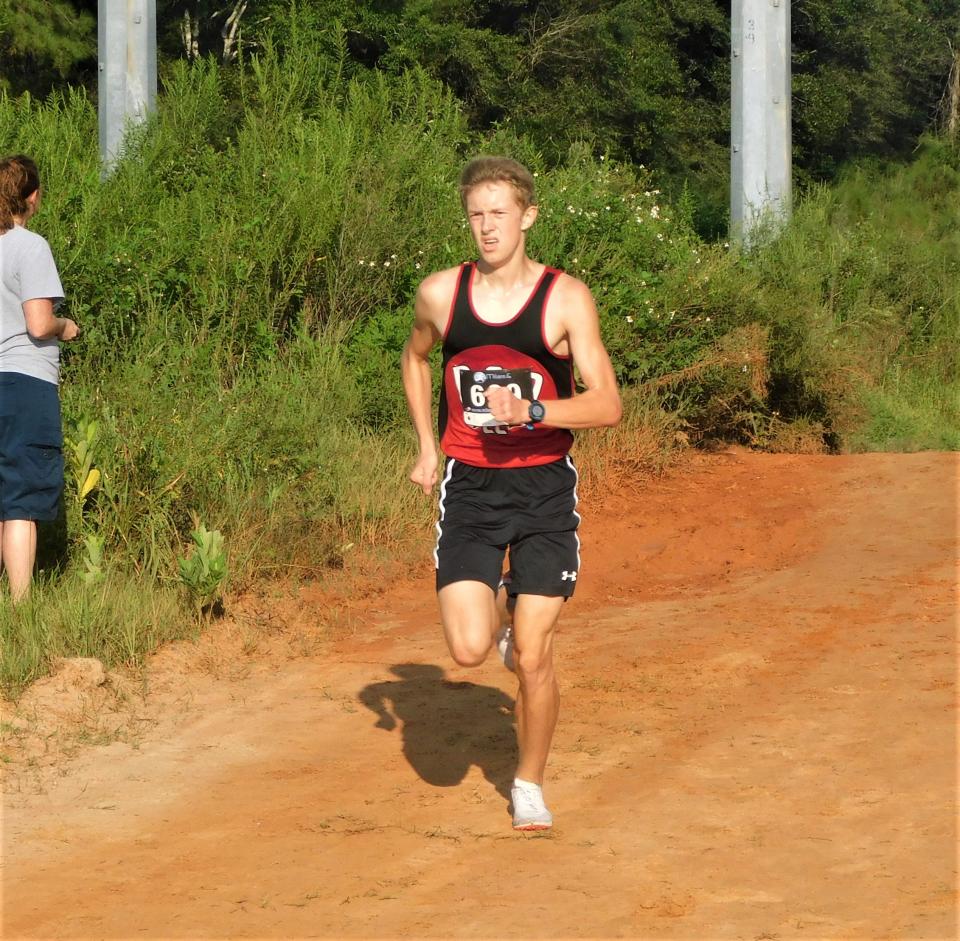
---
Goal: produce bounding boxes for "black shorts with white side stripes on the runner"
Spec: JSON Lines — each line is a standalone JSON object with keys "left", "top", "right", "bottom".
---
{"left": 434, "top": 456, "right": 580, "bottom": 598}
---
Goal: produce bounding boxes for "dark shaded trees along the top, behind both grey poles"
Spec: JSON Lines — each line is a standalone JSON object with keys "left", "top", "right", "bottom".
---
{"left": 0, "top": 0, "right": 960, "bottom": 234}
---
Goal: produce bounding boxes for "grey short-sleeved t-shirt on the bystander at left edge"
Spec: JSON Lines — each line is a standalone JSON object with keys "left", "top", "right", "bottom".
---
{"left": 0, "top": 225, "right": 63, "bottom": 384}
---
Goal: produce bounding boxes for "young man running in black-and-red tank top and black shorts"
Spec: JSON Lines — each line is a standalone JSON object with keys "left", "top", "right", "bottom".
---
{"left": 402, "top": 157, "right": 620, "bottom": 830}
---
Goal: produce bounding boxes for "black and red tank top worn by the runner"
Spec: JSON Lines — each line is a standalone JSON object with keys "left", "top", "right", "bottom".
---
{"left": 438, "top": 262, "right": 573, "bottom": 467}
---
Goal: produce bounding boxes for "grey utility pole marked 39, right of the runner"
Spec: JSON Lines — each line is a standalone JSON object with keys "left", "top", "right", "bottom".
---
{"left": 730, "top": 0, "right": 793, "bottom": 245}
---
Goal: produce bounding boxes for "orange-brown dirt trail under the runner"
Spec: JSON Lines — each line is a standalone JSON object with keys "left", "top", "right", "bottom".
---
{"left": 2, "top": 452, "right": 958, "bottom": 939}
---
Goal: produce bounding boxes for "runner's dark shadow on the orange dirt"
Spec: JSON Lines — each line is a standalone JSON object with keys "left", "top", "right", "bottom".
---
{"left": 358, "top": 663, "right": 517, "bottom": 800}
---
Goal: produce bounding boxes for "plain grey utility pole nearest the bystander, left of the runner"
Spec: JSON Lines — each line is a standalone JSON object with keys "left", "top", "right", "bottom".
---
{"left": 97, "top": 0, "right": 157, "bottom": 170}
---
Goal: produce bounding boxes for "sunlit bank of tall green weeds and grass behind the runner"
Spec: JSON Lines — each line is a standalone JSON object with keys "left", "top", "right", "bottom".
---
{"left": 0, "top": 18, "right": 960, "bottom": 684}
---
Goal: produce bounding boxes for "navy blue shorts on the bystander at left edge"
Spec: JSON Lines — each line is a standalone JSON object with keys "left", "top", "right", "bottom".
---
{"left": 0, "top": 372, "right": 63, "bottom": 522}
